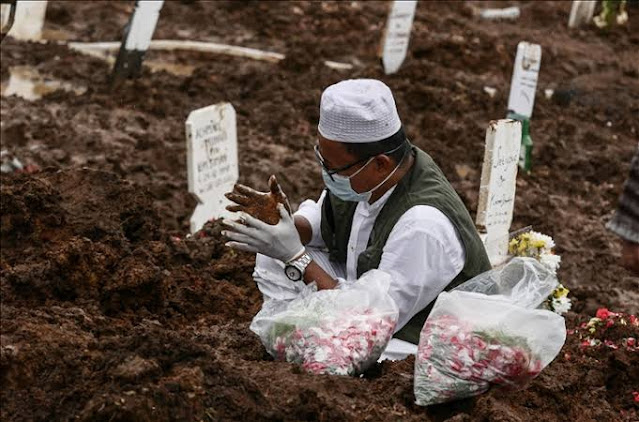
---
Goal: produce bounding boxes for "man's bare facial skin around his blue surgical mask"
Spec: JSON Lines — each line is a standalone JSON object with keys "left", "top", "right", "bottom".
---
{"left": 318, "top": 135, "right": 394, "bottom": 192}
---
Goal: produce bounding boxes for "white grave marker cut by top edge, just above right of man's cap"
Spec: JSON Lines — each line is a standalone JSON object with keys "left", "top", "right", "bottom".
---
{"left": 382, "top": 0, "right": 417, "bottom": 75}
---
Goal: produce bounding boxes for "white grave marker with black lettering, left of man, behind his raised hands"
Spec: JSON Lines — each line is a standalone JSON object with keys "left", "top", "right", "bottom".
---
{"left": 186, "top": 103, "right": 239, "bottom": 233}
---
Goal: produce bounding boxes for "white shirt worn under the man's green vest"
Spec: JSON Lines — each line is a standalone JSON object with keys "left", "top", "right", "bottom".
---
{"left": 295, "top": 188, "right": 466, "bottom": 332}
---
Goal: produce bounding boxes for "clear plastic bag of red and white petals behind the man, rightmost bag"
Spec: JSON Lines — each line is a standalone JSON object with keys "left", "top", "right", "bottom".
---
{"left": 414, "top": 258, "right": 566, "bottom": 406}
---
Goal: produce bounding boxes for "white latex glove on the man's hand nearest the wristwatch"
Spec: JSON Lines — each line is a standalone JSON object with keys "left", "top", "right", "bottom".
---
{"left": 222, "top": 204, "right": 304, "bottom": 262}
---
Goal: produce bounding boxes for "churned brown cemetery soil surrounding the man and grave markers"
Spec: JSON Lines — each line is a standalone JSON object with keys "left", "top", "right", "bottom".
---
{"left": 0, "top": 1, "right": 639, "bottom": 421}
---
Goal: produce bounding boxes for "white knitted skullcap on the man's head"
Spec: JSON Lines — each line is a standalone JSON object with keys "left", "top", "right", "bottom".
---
{"left": 317, "top": 79, "right": 402, "bottom": 144}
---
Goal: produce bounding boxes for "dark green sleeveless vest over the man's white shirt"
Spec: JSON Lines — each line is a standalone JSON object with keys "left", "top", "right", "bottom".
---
{"left": 321, "top": 147, "right": 491, "bottom": 344}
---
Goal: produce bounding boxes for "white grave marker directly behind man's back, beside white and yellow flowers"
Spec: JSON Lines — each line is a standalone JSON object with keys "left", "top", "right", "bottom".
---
{"left": 476, "top": 119, "right": 521, "bottom": 266}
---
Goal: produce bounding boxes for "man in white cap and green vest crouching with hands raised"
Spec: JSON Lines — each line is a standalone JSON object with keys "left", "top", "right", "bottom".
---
{"left": 224, "top": 79, "right": 491, "bottom": 359}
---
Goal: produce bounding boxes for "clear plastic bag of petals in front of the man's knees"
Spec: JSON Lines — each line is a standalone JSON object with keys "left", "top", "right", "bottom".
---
{"left": 250, "top": 270, "right": 398, "bottom": 376}
